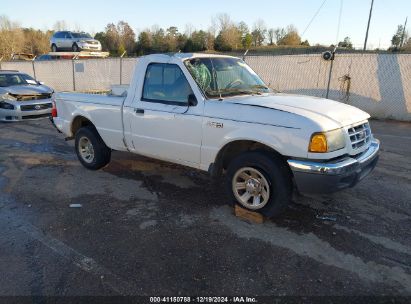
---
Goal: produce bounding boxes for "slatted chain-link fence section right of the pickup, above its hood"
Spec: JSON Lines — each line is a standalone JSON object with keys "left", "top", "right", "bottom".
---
{"left": 246, "top": 54, "right": 411, "bottom": 121}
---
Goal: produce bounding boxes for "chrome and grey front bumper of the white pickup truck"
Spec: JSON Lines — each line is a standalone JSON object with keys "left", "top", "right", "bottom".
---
{"left": 288, "top": 139, "right": 380, "bottom": 193}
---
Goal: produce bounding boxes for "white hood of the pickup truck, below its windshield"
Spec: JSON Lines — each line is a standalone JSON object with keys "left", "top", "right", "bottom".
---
{"left": 224, "top": 93, "right": 370, "bottom": 129}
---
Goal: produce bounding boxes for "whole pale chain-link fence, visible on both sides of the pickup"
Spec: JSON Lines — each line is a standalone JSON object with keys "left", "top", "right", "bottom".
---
{"left": 1, "top": 54, "right": 411, "bottom": 121}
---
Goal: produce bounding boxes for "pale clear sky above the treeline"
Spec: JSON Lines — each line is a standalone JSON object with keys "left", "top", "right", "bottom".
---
{"left": 0, "top": 0, "right": 411, "bottom": 48}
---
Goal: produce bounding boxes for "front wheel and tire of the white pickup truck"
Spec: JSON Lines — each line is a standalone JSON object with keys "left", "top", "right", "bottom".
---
{"left": 226, "top": 151, "right": 293, "bottom": 218}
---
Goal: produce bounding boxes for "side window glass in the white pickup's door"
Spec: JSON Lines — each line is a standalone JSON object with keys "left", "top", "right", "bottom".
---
{"left": 143, "top": 63, "right": 193, "bottom": 105}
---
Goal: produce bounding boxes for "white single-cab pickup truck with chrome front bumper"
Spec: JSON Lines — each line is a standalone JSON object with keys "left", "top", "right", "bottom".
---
{"left": 52, "top": 53, "right": 379, "bottom": 217}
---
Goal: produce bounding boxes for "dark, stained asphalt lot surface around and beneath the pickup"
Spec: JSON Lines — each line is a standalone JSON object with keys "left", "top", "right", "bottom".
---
{"left": 0, "top": 119, "right": 411, "bottom": 296}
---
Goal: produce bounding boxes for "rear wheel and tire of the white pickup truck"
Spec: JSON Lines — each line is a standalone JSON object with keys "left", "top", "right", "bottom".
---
{"left": 75, "top": 126, "right": 111, "bottom": 170}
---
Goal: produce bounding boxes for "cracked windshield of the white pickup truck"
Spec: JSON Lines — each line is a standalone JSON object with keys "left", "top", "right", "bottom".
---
{"left": 184, "top": 57, "right": 272, "bottom": 98}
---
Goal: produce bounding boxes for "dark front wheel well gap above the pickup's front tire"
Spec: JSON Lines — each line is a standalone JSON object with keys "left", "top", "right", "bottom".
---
{"left": 210, "top": 140, "right": 285, "bottom": 177}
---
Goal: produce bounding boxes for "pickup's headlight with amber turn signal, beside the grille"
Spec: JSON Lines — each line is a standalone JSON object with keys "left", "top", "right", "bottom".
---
{"left": 308, "top": 129, "right": 345, "bottom": 153}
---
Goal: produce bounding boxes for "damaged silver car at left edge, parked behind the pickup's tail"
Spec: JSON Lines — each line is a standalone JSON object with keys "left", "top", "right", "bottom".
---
{"left": 0, "top": 70, "right": 54, "bottom": 121}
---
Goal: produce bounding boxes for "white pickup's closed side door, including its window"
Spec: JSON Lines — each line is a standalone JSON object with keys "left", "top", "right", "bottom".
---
{"left": 128, "top": 63, "right": 204, "bottom": 167}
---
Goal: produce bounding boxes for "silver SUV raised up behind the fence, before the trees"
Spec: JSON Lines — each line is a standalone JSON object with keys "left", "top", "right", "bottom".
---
{"left": 50, "top": 31, "right": 101, "bottom": 52}
